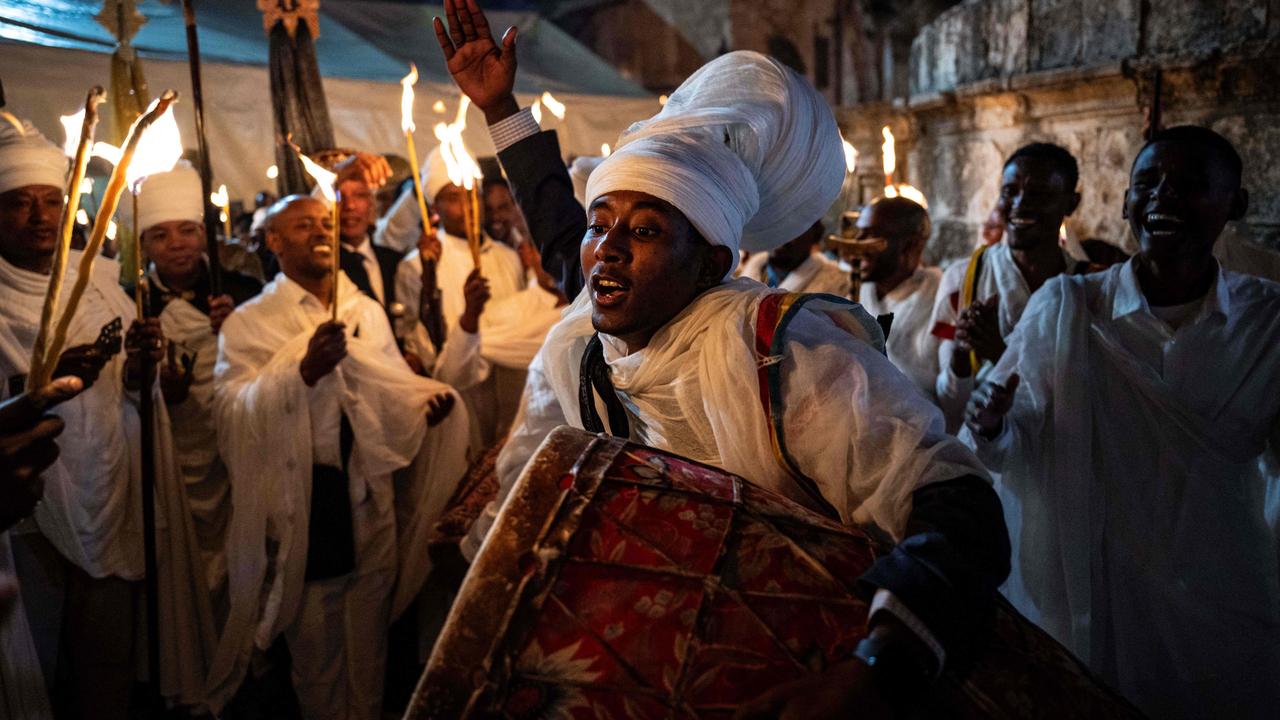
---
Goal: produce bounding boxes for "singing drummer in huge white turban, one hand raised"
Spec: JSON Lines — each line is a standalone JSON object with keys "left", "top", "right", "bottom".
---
{"left": 435, "top": 0, "right": 1009, "bottom": 716}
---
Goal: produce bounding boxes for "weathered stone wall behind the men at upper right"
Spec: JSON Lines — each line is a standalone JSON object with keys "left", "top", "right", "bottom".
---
{"left": 840, "top": 0, "right": 1280, "bottom": 274}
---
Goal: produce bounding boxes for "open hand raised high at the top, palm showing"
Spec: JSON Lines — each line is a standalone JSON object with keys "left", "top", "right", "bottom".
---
{"left": 434, "top": 0, "right": 520, "bottom": 124}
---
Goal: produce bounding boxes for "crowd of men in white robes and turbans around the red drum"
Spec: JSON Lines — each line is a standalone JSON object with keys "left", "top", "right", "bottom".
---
{"left": 0, "top": 0, "right": 1280, "bottom": 719}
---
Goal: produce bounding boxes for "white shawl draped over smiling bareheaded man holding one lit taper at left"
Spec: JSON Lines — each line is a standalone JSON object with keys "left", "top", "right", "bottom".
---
{"left": 210, "top": 274, "right": 468, "bottom": 708}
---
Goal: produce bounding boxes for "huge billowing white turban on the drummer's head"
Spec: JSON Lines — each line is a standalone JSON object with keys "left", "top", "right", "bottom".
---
{"left": 586, "top": 51, "right": 845, "bottom": 269}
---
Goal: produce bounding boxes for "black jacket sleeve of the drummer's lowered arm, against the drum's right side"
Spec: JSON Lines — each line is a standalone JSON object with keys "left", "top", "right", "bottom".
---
{"left": 859, "top": 475, "right": 1010, "bottom": 665}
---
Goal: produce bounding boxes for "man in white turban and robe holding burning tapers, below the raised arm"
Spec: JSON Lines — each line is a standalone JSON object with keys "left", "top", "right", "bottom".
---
{"left": 379, "top": 142, "right": 547, "bottom": 450}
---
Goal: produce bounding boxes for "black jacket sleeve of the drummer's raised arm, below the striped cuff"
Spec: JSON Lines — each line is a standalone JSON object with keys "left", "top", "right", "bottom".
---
{"left": 498, "top": 131, "right": 586, "bottom": 300}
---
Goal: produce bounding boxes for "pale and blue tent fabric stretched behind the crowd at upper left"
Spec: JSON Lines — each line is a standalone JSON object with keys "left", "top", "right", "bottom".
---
{"left": 0, "top": 0, "right": 659, "bottom": 203}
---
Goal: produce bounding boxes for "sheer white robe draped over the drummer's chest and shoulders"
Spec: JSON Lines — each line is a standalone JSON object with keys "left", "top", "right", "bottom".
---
{"left": 465, "top": 278, "right": 987, "bottom": 552}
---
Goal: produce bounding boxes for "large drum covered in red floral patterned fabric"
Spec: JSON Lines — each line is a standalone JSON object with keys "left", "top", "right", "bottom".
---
{"left": 406, "top": 428, "right": 1138, "bottom": 719}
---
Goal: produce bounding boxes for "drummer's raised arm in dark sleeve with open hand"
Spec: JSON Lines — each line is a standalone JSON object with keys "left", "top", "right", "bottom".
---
{"left": 435, "top": 0, "right": 586, "bottom": 294}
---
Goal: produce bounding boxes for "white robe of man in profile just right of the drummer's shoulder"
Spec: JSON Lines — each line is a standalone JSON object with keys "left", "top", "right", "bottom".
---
{"left": 858, "top": 268, "right": 942, "bottom": 400}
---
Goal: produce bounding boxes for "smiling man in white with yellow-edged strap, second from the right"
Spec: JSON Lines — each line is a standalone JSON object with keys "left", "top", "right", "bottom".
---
{"left": 931, "top": 142, "right": 1087, "bottom": 433}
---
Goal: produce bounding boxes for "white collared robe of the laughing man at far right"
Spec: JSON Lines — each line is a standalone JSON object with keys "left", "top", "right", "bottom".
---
{"left": 963, "top": 260, "right": 1280, "bottom": 719}
